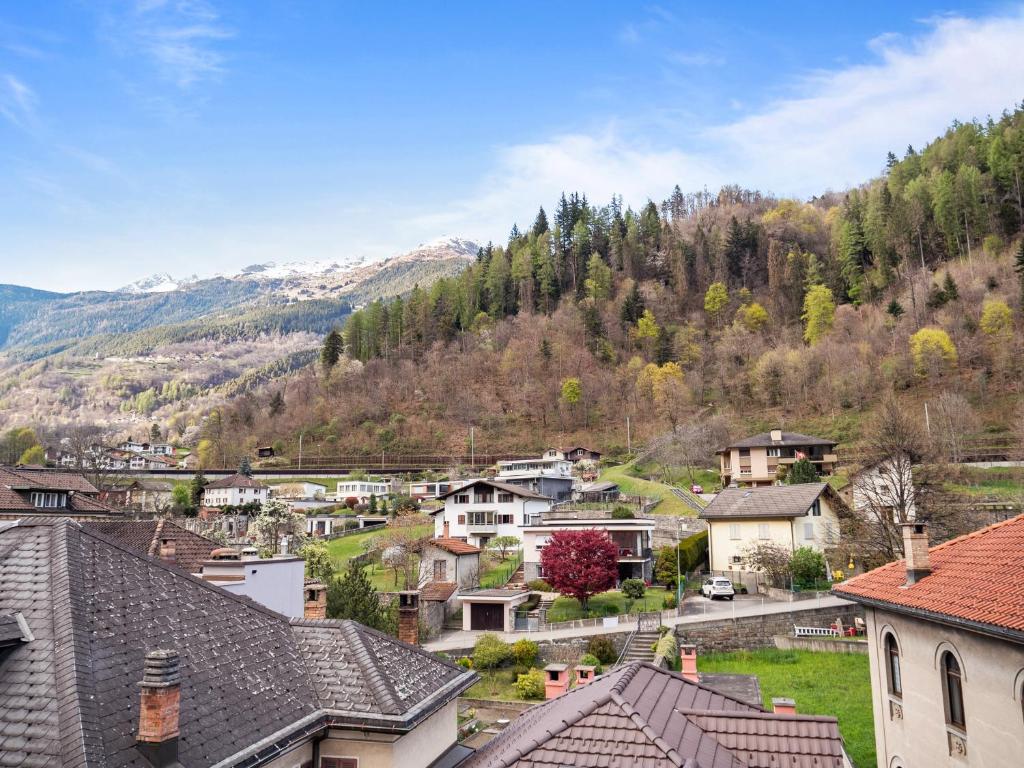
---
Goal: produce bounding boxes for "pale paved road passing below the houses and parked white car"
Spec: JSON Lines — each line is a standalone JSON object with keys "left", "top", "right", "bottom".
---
{"left": 423, "top": 595, "right": 851, "bottom": 650}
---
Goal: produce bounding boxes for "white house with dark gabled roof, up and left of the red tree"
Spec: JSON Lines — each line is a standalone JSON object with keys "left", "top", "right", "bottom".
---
{"left": 430, "top": 479, "right": 551, "bottom": 547}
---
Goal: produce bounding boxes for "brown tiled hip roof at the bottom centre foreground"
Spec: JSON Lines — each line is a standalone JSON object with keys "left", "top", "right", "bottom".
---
{"left": 460, "top": 664, "right": 843, "bottom": 768}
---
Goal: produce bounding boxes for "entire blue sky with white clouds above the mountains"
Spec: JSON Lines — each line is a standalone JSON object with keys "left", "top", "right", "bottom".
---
{"left": 0, "top": 0, "right": 1024, "bottom": 290}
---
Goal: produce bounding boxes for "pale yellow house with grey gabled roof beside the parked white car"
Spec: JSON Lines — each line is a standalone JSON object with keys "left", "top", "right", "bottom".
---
{"left": 700, "top": 482, "right": 847, "bottom": 571}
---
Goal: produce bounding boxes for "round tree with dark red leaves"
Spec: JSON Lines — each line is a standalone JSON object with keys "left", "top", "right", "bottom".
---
{"left": 541, "top": 530, "right": 618, "bottom": 610}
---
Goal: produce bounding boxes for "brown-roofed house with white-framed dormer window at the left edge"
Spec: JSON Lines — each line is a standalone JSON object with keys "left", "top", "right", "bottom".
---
{"left": 0, "top": 467, "right": 124, "bottom": 520}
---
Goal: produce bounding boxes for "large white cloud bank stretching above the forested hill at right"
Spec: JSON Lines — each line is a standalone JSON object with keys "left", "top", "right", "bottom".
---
{"left": 398, "top": 13, "right": 1024, "bottom": 239}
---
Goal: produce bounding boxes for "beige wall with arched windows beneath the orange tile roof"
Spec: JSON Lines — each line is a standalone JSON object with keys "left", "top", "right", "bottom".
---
{"left": 866, "top": 609, "right": 1024, "bottom": 768}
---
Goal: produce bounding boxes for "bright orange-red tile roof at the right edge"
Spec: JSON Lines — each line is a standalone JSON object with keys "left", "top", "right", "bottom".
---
{"left": 833, "top": 515, "right": 1024, "bottom": 641}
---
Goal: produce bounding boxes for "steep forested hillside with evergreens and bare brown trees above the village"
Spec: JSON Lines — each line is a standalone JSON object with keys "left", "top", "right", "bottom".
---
{"left": 201, "top": 110, "right": 1024, "bottom": 466}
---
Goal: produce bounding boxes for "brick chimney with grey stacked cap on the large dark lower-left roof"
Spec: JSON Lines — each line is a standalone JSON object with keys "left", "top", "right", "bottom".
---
{"left": 135, "top": 650, "right": 181, "bottom": 768}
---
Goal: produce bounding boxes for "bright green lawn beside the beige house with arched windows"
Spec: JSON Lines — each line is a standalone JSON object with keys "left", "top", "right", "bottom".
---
{"left": 697, "top": 649, "right": 874, "bottom": 768}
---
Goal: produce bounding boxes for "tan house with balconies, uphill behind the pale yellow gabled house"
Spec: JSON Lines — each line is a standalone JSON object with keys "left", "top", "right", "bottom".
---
{"left": 718, "top": 429, "right": 839, "bottom": 487}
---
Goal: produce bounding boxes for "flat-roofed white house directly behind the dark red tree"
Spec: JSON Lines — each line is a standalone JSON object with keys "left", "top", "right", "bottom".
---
{"left": 522, "top": 509, "right": 654, "bottom": 582}
